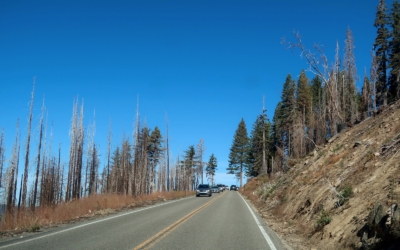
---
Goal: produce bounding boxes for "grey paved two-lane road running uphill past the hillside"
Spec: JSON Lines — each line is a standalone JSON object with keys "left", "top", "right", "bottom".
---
{"left": 0, "top": 191, "right": 284, "bottom": 250}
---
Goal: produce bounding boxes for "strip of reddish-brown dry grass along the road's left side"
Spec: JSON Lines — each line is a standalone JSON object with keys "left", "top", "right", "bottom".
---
{"left": 0, "top": 192, "right": 193, "bottom": 233}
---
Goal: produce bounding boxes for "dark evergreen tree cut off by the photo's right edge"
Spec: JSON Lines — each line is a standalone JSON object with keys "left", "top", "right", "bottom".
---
{"left": 388, "top": 0, "right": 400, "bottom": 102}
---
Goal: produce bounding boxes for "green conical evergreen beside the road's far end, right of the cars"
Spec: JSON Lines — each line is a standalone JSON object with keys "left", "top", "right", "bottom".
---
{"left": 227, "top": 118, "right": 249, "bottom": 187}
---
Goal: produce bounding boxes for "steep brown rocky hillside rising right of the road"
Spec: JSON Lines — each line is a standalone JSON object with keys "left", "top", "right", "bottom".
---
{"left": 241, "top": 102, "right": 400, "bottom": 249}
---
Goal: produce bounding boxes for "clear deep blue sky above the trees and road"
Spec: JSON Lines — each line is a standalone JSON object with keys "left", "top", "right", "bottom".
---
{"left": 0, "top": 0, "right": 392, "bottom": 188}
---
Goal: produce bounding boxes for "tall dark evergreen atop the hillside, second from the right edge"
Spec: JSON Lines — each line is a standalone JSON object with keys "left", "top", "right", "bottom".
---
{"left": 374, "top": 0, "right": 389, "bottom": 106}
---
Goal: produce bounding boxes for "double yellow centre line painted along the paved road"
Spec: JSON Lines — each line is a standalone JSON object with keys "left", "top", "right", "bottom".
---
{"left": 133, "top": 193, "right": 225, "bottom": 250}
